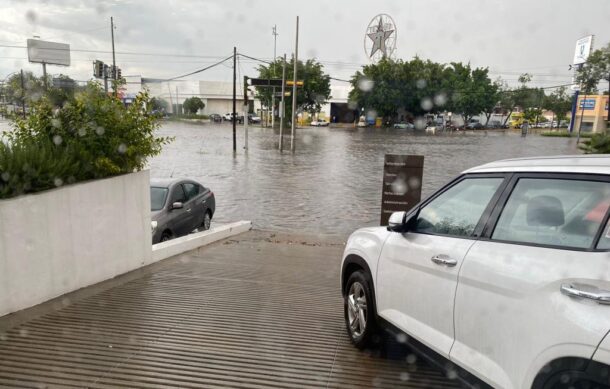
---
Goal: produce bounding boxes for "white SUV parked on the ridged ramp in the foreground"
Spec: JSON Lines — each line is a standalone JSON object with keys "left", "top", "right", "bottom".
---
{"left": 341, "top": 156, "right": 610, "bottom": 388}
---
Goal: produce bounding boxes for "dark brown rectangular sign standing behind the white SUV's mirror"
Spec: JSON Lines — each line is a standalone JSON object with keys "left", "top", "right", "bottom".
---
{"left": 380, "top": 154, "right": 424, "bottom": 226}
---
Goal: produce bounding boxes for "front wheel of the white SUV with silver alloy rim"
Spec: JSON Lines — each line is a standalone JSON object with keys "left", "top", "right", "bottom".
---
{"left": 343, "top": 270, "right": 377, "bottom": 349}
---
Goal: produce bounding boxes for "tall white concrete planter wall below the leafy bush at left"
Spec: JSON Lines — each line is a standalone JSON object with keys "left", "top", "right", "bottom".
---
{"left": 0, "top": 171, "right": 152, "bottom": 316}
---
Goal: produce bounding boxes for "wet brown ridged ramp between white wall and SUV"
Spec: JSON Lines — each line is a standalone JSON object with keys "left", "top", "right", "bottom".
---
{"left": 0, "top": 231, "right": 452, "bottom": 388}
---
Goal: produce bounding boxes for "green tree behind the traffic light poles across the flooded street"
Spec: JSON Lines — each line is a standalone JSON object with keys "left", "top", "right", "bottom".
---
{"left": 256, "top": 58, "right": 330, "bottom": 122}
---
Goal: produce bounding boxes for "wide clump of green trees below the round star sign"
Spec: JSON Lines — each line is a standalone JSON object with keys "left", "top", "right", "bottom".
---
{"left": 349, "top": 57, "right": 499, "bottom": 120}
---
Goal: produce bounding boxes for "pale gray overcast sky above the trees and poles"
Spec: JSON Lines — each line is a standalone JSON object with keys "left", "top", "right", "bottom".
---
{"left": 0, "top": 0, "right": 610, "bottom": 86}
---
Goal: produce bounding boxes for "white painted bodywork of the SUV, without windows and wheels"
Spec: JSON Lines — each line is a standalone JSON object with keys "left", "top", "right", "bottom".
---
{"left": 342, "top": 155, "right": 610, "bottom": 389}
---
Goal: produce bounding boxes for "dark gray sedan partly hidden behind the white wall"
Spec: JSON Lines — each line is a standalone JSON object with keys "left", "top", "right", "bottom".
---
{"left": 150, "top": 179, "right": 216, "bottom": 244}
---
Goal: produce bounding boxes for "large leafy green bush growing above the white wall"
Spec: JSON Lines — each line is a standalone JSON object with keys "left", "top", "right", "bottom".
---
{"left": 0, "top": 83, "right": 171, "bottom": 196}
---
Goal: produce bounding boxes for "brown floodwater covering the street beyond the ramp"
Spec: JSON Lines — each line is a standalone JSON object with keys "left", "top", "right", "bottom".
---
{"left": 149, "top": 122, "right": 578, "bottom": 235}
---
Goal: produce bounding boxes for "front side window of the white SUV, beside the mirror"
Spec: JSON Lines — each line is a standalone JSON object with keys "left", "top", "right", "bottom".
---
{"left": 415, "top": 178, "right": 504, "bottom": 236}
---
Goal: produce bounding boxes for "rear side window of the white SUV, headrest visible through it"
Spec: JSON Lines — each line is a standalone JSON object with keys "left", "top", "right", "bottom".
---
{"left": 491, "top": 178, "right": 610, "bottom": 248}
